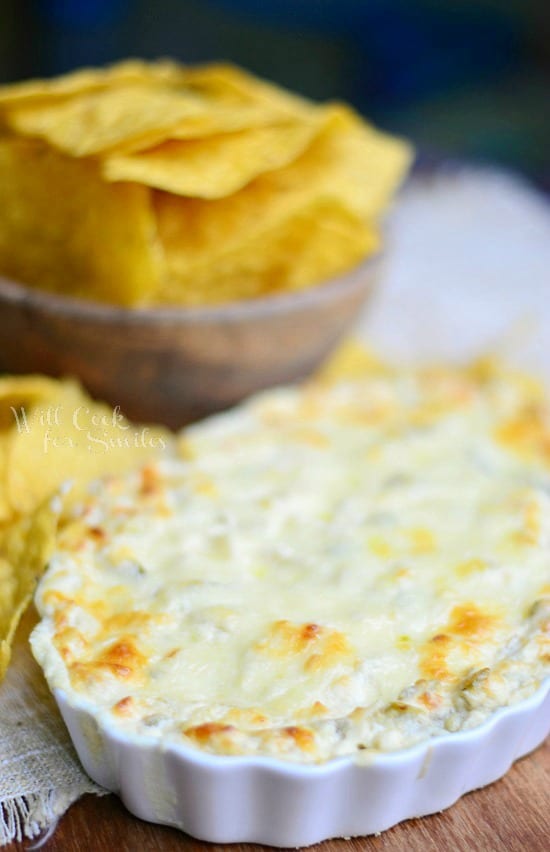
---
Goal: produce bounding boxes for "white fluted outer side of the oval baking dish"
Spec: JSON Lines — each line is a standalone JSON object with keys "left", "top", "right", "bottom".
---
{"left": 54, "top": 680, "right": 550, "bottom": 847}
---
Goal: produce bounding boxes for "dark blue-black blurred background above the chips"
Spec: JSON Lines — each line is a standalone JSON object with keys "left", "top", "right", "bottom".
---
{"left": 0, "top": 0, "right": 550, "bottom": 190}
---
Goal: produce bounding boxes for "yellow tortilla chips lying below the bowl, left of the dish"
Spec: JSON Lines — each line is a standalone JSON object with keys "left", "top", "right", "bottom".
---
{"left": 0, "top": 376, "right": 172, "bottom": 680}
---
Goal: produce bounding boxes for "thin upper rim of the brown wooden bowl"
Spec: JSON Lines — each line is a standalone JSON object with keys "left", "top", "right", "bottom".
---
{"left": 0, "top": 251, "right": 382, "bottom": 326}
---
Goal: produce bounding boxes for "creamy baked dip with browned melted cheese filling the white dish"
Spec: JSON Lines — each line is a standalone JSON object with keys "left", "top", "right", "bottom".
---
{"left": 32, "top": 367, "right": 550, "bottom": 762}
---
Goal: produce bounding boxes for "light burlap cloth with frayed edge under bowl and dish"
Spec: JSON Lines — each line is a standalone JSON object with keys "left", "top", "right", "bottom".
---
{"left": 0, "top": 169, "right": 550, "bottom": 845}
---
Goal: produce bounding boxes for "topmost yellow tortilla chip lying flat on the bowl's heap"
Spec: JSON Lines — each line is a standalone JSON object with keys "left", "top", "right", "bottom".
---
{"left": 0, "top": 61, "right": 320, "bottom": 158}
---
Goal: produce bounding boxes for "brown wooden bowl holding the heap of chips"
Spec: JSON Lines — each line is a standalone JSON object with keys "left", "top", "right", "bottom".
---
{"left": 0, "top": 258, "right": 378, "bottom": 428}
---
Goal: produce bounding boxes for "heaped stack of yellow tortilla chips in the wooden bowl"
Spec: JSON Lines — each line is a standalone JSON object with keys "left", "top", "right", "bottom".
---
{"left": 0, "top": 61, "right": 411, "bottom": 307}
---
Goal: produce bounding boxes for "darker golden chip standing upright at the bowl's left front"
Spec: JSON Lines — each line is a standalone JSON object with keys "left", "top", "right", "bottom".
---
{"left": 0, "top": 138, "right": 160, "bottom": 305}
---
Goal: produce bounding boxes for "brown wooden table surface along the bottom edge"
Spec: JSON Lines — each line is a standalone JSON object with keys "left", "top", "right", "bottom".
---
{"left": 2, "top": 741, "right": 550, "bottom": 852}
